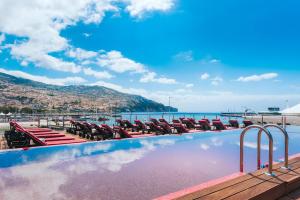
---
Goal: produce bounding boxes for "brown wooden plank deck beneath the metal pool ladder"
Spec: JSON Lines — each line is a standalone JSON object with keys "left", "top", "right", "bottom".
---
{"left": 157, "top": 155, "right": 300, "bottom": 200}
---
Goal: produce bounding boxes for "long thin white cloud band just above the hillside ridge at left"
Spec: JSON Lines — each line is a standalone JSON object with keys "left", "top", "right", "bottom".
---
{"left": 0, "top": 68, "right": 86, "bottom": 85}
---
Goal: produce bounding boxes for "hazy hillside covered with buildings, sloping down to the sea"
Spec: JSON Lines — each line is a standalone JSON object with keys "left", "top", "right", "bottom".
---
{"left": 0, "top": 73, "right": 177, "bottom": 112}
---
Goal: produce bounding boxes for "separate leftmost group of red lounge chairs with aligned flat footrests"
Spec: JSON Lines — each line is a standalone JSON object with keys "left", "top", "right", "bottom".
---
{"left": 4, "top": 121, "right": 86, "bottom": 148}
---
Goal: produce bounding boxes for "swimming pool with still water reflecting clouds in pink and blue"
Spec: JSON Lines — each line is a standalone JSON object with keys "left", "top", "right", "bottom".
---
{"left": 0, "top": 126, "right": 300, "bottom": 200}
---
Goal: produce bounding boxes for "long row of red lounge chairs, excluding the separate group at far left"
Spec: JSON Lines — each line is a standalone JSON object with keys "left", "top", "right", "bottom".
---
{"left": 67, "top": 118, "right": 252, "bottom": 140}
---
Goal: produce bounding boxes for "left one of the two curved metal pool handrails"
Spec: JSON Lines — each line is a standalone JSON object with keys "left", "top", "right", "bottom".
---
{"left": 240, "top": 125, "right": 273, "bottom": 175}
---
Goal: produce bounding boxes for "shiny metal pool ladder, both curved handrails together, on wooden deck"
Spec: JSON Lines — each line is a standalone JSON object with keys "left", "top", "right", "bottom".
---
{"left": 240, "top": 124, "right": 289, "bottom": 176}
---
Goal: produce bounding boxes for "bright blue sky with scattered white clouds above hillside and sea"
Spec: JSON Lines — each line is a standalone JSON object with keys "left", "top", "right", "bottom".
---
{"left": 0, "top": 0, "right": 300, "bottom": 112}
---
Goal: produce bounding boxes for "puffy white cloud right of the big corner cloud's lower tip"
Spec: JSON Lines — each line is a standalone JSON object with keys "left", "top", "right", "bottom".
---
{"left": 98, "top": 51, "right": 145, "bottom": 73}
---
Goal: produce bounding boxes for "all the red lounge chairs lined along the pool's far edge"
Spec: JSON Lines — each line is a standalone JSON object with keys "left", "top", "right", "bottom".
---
{"left": 5, "top": 118, "right": 253, "bottom": 148}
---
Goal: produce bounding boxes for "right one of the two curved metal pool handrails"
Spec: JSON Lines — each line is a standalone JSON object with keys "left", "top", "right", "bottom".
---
{"left": 257, "top": 124, "right": 289, "bottom": 169}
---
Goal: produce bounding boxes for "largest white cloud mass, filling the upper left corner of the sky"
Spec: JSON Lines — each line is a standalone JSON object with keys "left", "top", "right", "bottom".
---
{"left": 0, "top": 0, "right": 115, "bottom": 73}
